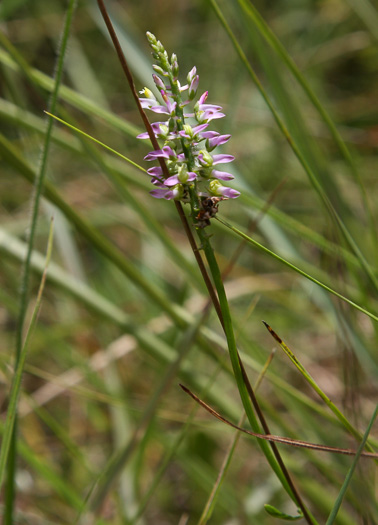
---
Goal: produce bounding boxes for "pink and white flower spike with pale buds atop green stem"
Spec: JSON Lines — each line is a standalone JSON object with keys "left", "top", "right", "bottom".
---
{"left": 138, "top": 33, "right": 240, "bottom": 223}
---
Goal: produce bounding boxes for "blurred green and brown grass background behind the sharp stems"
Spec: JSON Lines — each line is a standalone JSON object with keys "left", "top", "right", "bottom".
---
{"left": 0, "top": 0, "right": 378, "bottom": 525}
